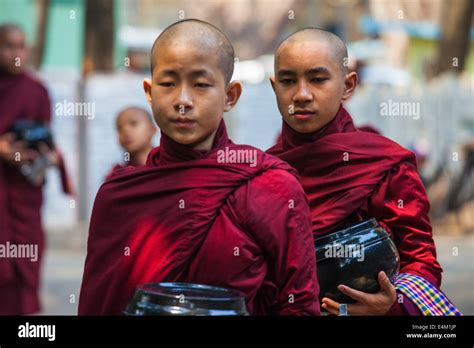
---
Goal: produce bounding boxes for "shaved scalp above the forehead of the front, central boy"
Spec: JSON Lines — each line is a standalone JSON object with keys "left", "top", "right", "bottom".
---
{"left": 150, "top": 19, "right": 235, "bottom": 84}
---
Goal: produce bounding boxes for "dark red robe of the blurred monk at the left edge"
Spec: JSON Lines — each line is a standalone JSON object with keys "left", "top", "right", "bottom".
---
{"left": 0, "top": 72, "right": 72, "bottom": 315}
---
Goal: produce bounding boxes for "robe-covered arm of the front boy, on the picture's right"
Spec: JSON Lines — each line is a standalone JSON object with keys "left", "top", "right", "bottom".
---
{"left": 245, "top": 170, "right": 320, "bottom": 315}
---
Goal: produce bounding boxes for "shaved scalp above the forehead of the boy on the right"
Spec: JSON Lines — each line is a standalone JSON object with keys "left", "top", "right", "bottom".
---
{"left": 275, "top": 28, "right": 348, "bottom": 75}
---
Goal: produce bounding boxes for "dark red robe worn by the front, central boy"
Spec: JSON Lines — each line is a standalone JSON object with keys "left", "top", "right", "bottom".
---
{"left": 79, "top": 121, "right": 319, "bottom": 315}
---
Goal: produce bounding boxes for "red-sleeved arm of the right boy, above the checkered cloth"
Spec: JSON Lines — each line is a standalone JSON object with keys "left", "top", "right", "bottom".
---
{"left": 373, "top": 163, "right": 442, "bottom": 314}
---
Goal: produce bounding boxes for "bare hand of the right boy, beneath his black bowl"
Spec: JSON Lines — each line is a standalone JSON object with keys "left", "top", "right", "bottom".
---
{"left": 322, "top": 271, "right": 397, "bottom": 315}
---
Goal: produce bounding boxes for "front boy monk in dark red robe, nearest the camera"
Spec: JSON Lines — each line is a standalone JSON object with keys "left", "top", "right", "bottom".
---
{"left": 79, "top": 20, "right": 319, "bottom": 315}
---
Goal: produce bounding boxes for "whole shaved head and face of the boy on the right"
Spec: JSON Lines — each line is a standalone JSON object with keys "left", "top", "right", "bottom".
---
{"left": 270, "top": 28, "right": 357, "bottom": 133}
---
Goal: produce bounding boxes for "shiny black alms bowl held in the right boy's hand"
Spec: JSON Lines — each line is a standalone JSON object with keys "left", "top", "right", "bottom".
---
{"left": 315, "top": 219, "right": 400, "bottom": 303}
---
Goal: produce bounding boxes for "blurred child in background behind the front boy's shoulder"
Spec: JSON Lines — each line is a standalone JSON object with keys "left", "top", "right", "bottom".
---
{"left": 107, "top": 106, "right": 156, "bottom": 179}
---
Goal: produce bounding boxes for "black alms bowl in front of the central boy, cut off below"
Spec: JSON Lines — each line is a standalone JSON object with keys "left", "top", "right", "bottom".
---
{"left": 124, "top": 283, "right": 248, "bottom": 316}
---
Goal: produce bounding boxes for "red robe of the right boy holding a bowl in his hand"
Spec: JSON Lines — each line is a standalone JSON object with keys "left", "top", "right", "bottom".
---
{"left": 267, "top": 106, "right": 442, "bottom": 314}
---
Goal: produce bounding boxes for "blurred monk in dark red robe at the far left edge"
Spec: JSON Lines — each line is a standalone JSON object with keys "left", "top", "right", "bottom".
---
{"left": 0, "top": 24, "right": 71, "bottom": 315}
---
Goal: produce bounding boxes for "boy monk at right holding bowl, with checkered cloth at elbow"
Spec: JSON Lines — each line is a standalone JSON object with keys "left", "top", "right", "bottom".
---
{"left": 268, "top": 29, "right": 459, "bottom": 315}
